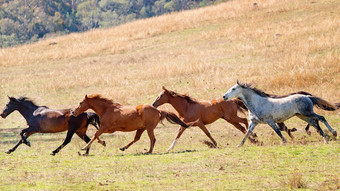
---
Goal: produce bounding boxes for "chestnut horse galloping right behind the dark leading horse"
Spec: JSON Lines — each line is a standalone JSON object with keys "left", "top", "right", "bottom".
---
{"left": 73, "top": 94, "right": 188, "bottom": 153}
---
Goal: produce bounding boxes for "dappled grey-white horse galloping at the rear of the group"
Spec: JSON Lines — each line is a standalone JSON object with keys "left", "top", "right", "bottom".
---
{"left": 223, "top": 81, "right": 337, "bottom": 147}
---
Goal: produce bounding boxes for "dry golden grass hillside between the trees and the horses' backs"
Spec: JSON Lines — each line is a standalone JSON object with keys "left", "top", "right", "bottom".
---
{"left": 0, "top": 0, "right": 340, "bottom": 106}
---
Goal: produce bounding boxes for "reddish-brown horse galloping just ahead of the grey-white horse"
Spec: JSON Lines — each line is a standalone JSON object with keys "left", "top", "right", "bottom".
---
{"left": 152, "top": 86, "right": 255, "bottom": 151}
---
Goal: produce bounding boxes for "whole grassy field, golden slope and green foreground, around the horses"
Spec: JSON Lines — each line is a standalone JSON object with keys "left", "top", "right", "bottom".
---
{"left": 0, "top": 0, "right": 340, "bottom": 190}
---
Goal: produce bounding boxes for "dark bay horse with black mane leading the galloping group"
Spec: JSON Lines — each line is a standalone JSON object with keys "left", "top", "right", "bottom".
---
{"left": 0, "top": 97, "right": 100, "bottom": 155}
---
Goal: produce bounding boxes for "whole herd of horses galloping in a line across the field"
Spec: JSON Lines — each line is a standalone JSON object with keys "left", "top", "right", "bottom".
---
{"left": 0, "top": 81, "right": 340, "bottom": 155}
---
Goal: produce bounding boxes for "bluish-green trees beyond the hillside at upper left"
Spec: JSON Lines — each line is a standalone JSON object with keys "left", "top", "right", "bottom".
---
{"left": 0, "top": 0, "right": 225, "bottom": 48}
